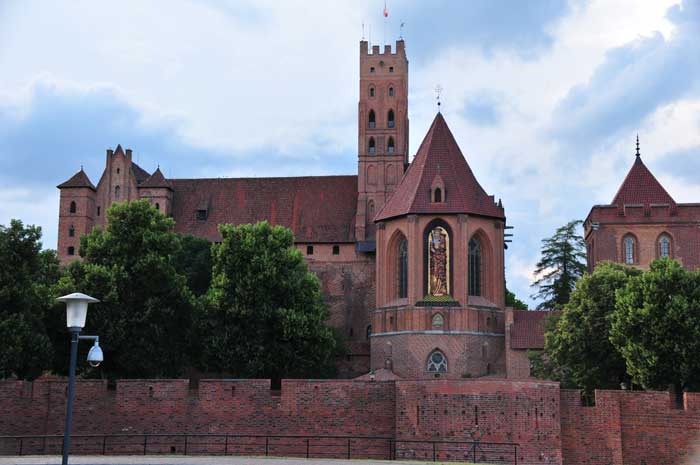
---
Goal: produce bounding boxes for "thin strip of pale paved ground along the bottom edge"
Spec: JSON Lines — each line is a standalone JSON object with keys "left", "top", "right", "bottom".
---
{"left": 0, "top": 455, "right": 460, "bottom": 465}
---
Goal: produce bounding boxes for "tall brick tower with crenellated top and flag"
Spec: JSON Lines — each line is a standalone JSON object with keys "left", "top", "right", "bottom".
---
{"left": 355, "top": 40, "right": 408, "bottom": 242}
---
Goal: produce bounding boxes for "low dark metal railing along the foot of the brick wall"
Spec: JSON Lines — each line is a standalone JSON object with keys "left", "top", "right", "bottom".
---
{"left": 0, "top": 433, "right": 518, "bottom": 465}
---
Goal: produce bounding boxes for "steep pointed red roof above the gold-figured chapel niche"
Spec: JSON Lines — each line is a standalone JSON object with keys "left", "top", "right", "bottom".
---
{"left": 375, "top": 113, "right": 505, "bottom": 221}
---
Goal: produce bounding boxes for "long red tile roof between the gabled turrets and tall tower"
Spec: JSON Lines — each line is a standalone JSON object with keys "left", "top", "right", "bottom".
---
{"left": 169, "top": 176, "right": 357, "bottom": 243}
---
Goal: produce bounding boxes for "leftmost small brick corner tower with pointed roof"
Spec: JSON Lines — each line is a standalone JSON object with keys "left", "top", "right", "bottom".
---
{"left": 56, "top": 167, "right": 96, "bottom": 265}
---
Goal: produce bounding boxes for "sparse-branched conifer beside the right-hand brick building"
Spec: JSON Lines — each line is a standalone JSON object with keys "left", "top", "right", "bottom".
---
{"left": 532, "top": 221, "right": 586, "bottom": 310}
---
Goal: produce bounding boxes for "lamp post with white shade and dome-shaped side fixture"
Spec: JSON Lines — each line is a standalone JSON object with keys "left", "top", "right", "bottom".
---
{"left": 56, "top": 292, "right": 104, "bottom": 465}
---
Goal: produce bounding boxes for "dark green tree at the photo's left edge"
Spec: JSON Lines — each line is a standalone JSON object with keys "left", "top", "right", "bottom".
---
{"left": 0, "top": 220, "right": 59, "bottom": 379}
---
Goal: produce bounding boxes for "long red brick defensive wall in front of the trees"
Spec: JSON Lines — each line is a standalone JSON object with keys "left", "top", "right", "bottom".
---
{"left": 0, "top": 378, "right": 700, "bottom": 465}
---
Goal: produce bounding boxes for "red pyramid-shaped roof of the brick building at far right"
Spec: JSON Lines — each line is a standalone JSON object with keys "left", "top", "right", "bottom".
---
{"left": 612, "top": 155, "right": 676, "bottom": 207}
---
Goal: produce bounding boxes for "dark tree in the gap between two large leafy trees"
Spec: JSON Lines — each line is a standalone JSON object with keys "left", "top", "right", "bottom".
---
{"left": 173, "top": 235, "right": 212, "bottom": 296}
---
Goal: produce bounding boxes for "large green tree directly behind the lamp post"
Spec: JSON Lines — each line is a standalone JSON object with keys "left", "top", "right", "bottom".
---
{"left": 50, "top": 201, "right": 194, "bottom": 378}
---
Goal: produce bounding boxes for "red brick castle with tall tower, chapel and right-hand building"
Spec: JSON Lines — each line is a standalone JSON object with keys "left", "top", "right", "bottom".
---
{"left": 58, "top": 40, "right": 700, "bottom": 380}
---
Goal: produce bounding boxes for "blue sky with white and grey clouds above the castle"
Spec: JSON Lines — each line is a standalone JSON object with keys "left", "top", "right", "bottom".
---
{"left": 0, "top": 0, "right": 700, "bottom": 305}
